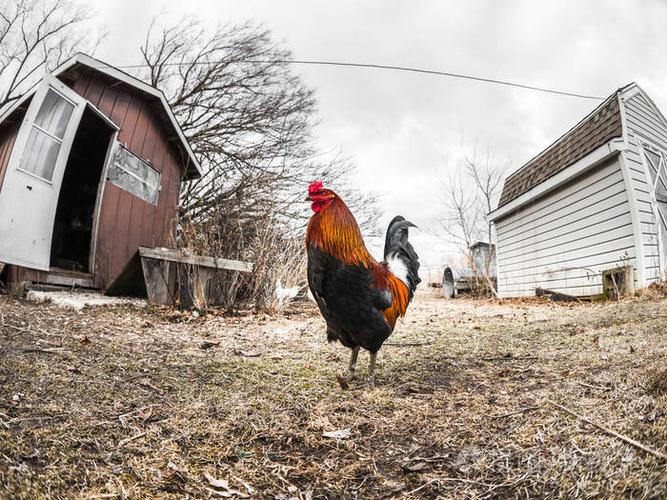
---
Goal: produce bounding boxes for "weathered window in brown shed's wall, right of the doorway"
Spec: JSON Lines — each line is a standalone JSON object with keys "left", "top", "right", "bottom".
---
{"left": 107, "top": 144, "right": 160, "bottom": 205}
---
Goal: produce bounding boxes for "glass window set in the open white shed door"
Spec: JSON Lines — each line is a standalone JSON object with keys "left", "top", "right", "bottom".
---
{"left": 19, "top": 89, "right": 74, "bottom": 182}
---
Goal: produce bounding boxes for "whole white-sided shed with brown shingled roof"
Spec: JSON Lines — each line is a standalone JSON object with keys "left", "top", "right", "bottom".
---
{"left": 489, "top": 83, "right": 667, "bottom": 297}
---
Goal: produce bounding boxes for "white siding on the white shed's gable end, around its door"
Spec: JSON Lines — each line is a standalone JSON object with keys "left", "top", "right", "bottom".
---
{"left": 623, "top": 91, "right": 667, "bottom": 285}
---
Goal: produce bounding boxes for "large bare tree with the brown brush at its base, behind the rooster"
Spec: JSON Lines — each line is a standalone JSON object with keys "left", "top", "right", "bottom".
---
{"left": 139, "top": 20, "right": 378, "bottom": 308}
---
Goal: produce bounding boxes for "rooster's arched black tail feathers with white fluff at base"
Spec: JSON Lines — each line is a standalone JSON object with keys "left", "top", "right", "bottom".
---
{"left": 384, "top": 215, "right": 421, "bottom": 298}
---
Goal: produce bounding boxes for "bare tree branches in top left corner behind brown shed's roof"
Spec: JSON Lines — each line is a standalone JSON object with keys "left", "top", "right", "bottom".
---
{"left": 0, "top": 0, "right": 99, "bottom": 108}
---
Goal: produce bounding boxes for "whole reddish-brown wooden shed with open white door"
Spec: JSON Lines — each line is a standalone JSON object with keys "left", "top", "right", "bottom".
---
{"left": 0, "top": 54, "right": 201, "bottom": 289}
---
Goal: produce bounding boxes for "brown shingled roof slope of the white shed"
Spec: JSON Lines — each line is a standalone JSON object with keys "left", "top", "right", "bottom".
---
{"left": 498, "top": 84, "right": 632, "bottom": 207}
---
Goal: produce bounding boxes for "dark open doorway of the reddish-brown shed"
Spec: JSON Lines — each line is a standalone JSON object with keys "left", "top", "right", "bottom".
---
{"left": 51, "top": 107, "right": 114, "bottom": 273}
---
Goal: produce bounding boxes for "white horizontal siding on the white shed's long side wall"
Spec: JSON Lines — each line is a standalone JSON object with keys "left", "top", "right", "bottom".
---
{"left": 496, "top": 158, "right": 636, "bottom": 297}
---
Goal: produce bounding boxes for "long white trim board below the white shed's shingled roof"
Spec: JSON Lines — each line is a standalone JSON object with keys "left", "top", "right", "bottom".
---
{"left": 488, "top": 139, "right": 627, "bottom": 222}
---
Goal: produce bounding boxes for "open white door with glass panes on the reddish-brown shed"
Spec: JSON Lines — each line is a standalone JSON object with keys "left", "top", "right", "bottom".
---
{"left": 0, "top": 76, "right": 86, "bottom": 271}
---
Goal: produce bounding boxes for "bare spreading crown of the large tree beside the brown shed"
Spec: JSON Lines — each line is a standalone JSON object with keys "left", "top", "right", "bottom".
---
{"left": 141, "top": 20, "right": 380, "bottom": 227}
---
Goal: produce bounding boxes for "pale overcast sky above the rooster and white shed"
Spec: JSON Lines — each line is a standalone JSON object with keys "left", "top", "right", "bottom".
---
{"left": 93, "top": 0, "right": 667, "bottom": 282}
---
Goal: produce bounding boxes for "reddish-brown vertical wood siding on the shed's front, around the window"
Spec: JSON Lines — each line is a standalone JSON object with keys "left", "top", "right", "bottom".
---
{"left": 73, "top": 73, "right": 181, "bottom": 288}
